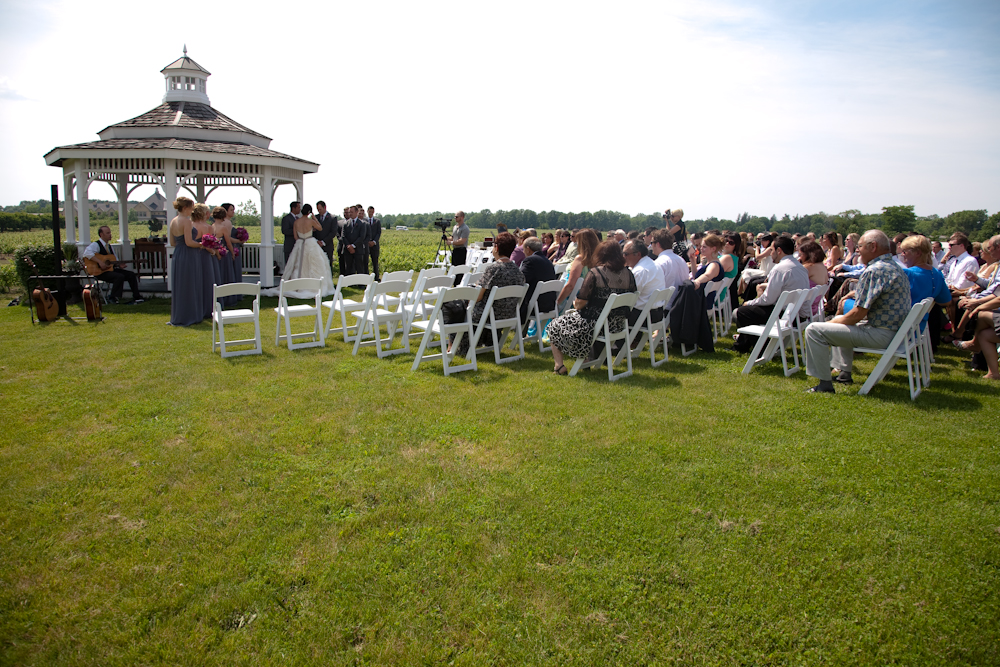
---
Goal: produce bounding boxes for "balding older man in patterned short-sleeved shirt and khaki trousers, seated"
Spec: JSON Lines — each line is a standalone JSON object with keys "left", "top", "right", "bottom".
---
{"left": 805, "top": 229, "right": 910, "bottom": 393}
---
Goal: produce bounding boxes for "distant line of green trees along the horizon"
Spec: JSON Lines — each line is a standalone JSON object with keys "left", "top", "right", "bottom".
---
{"left": 0, "top": 199, "right": 1000, "bottom": 241}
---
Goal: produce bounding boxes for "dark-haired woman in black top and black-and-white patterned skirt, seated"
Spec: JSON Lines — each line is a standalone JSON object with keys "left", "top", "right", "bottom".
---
{"left": 549, "top": 240, "right": 636, "bottom": 375}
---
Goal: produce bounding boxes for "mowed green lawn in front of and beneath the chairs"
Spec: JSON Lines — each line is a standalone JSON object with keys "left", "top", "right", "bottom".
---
{"left": 0, "top": 299, "right": 1000, "bottom": 665}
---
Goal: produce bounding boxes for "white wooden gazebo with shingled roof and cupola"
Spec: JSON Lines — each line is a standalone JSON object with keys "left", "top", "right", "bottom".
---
{"left": 45, "top": 47, "right": 319, "bottom": 287}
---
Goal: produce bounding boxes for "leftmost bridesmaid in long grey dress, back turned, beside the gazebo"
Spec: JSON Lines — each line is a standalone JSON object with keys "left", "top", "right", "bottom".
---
{"left": 170, "top": 197, "right": 212, "bottom": 327}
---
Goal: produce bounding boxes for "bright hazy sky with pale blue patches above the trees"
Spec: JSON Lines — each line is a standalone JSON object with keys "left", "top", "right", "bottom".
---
{"left": 0, "top": 0, "right": 1000, "bottom": 218}
